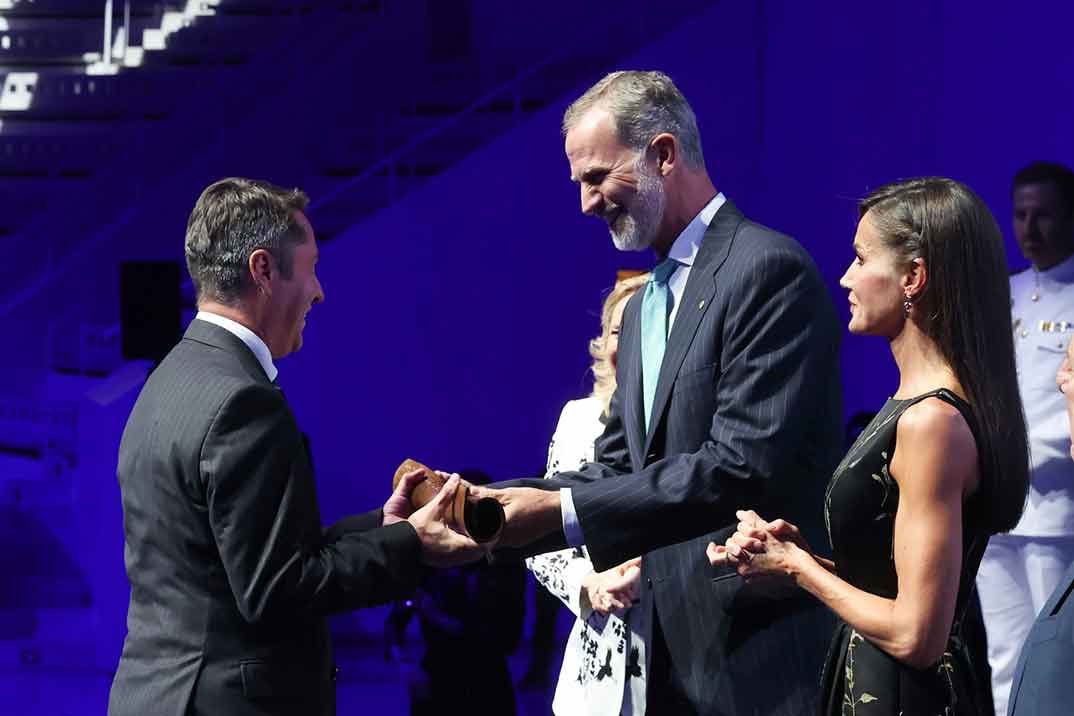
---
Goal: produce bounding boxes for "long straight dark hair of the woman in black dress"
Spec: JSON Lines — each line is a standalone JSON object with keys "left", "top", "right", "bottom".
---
{"left": 859, "top": 177, "right": 1029, "bottom": 532}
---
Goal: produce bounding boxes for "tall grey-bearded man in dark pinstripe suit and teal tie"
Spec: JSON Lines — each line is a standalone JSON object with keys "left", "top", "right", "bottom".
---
{"left": 474, "top": 72, "right": 841, "bottom": 716}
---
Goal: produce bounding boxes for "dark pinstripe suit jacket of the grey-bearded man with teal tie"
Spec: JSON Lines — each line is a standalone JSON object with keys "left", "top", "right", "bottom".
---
{"left": 515, "top": 202, "right": 842, "bottom": 716}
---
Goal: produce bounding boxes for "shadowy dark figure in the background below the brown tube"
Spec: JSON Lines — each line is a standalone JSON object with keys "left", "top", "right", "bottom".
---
{"left": 384, "top": 470, "right": 525, "bottom": 716}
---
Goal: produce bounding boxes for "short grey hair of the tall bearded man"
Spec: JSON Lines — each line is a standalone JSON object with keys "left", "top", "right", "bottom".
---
{"left": 563, "top": 71, "right": 705, "bottom": 169}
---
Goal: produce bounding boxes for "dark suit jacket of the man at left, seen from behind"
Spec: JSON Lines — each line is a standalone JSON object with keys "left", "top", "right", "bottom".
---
{"left": 108, "top": 320, "right": 421, "bottom": 716}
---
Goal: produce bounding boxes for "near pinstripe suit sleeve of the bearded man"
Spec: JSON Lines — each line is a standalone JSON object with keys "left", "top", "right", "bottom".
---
{"left": 560, "top": 243, "right": 839, "bottom": 570}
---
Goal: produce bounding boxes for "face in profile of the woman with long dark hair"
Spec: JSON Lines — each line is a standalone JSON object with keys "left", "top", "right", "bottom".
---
{"left": 839, "top": 211, "right": 905, "bottom": 338}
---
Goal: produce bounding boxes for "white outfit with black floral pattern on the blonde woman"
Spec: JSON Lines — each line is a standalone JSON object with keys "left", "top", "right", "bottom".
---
{"left": 526, "top": 397, "right": 650, "bottom": 716}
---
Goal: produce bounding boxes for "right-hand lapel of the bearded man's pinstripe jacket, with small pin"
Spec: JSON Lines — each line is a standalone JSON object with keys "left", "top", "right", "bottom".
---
{"left": 637, "top": 200, "right": 744, "bottom": 455}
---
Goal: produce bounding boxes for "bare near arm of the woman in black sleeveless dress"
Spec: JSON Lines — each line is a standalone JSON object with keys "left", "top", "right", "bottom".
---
{"left": 710, "top": 399, "right": 978, "bottom": 669}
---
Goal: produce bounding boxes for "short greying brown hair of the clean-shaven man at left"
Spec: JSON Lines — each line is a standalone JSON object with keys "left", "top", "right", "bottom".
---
{"left": 186, "top": 177, "right": 309, "bottom": 305}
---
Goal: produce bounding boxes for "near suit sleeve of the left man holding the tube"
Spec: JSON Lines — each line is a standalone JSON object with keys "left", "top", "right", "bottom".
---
{"left": 200, "top": 385, "right": 422, "bottom": 623}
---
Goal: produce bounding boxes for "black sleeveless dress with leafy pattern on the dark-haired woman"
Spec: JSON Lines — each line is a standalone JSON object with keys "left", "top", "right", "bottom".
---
{"left": 821, "top": 389, "right": 988, "bottom": 716}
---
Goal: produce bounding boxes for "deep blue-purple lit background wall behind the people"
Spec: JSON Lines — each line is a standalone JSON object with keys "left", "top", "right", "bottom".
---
{"left": 0, "top": 0, "right": 1074, "bottom": 713}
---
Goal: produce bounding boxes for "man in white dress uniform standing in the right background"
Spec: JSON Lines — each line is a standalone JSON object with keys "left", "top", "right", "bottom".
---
{"left": 977, "top": 162, "right": 1074, "bottom": 716}
